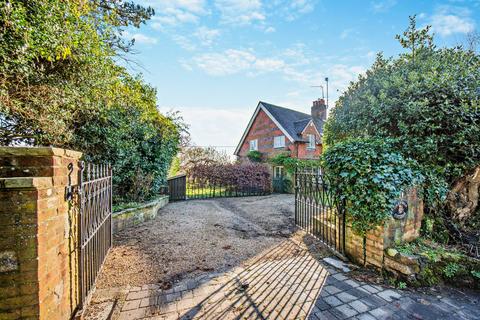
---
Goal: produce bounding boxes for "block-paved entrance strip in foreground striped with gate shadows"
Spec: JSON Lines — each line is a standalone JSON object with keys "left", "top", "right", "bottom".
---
{"left": 111, "top": 240, "right": 480, "bottom": 320}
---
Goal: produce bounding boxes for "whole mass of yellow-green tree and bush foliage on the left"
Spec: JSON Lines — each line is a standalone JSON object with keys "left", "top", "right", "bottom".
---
{"left": 0, "top": 0, "right": 185, "bottom": 202}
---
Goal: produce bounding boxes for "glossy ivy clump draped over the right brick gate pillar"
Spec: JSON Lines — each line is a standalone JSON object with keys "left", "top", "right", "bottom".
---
{"left": 322, "top": 139, "right": 423, "bottom": 236}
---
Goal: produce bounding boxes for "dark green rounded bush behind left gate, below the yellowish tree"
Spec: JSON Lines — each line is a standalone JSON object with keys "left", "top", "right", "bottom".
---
{"left": 74, "top": 96, "right": 180, "bottom": 203}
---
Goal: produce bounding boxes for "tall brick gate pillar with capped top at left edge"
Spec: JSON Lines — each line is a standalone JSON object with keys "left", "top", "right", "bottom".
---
{"left": 0, "top": 147, "right": 81, "bottom": 320}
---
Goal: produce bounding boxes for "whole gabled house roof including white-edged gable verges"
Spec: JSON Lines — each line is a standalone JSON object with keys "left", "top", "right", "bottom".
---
{"left": 234, "top": 101, "right": 323, "bottom": 154}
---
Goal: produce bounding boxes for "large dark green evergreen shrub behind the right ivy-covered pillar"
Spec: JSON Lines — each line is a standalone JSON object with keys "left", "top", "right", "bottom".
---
{"left": 324, "top": 17, "right": 480, "bottom": 255}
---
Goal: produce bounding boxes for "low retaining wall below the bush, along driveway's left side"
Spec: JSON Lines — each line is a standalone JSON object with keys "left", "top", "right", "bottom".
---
{"left": 112, "top": 195, "right": 168, "bottom": 233}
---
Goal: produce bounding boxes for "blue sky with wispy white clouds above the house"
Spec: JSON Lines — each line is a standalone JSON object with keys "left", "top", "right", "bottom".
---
{"left": 126, "top": 0, "right": 480, "bottom": 151}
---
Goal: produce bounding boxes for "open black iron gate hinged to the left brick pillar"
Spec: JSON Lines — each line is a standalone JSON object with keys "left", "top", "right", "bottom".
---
{"left": 77, "top": 162, "right": 112, "bottom": 309}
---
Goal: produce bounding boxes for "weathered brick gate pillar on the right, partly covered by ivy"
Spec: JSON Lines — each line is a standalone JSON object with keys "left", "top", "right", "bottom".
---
{"left": 345, "top": 189, "right": 423, "bottom": 268}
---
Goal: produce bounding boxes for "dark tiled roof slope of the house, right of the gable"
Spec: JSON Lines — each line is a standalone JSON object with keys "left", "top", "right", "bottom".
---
{"left": 260, "top": 101, "right": 312, "bottom": 141}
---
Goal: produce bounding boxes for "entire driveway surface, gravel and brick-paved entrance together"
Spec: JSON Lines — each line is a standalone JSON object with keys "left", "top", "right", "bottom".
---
{"left": 84, "top": 195, "right": 480, "bottom": 320}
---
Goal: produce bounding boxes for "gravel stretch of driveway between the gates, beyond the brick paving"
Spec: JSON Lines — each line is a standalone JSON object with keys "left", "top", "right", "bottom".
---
{"left": 97, "top": 195, "right": 308, "bottom": 289}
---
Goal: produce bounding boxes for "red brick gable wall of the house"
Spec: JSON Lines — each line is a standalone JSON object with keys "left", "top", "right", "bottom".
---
{"left": 239, "top": 110, "right": 296, "bottom": 157}
